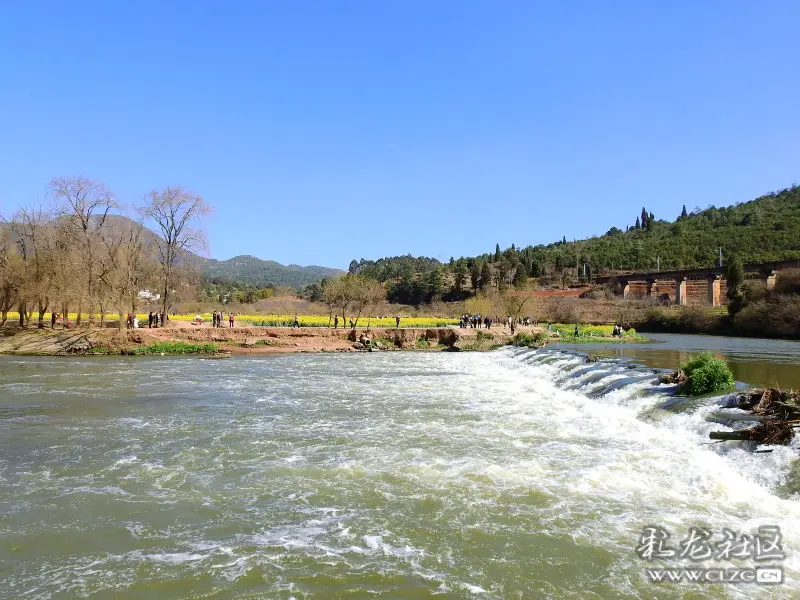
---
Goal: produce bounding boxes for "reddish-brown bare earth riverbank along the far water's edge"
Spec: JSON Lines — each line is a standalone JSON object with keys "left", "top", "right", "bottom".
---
{"left": 0, "top": 323, "right": 510, "bottom": 356}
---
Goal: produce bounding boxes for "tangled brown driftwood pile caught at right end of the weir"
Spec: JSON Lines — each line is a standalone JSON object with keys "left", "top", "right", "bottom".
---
{"left": 709, "top": 388, "right": 800, "bottom": 445}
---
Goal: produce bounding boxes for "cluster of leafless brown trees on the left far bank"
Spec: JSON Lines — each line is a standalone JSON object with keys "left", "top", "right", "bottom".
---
{"left": 0, "top": 177, "right": 210, "bottom": 328}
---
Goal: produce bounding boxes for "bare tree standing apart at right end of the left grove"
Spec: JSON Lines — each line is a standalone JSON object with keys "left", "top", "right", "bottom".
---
{"left": 143, "top": 187, "right": 211, "bottom": 320}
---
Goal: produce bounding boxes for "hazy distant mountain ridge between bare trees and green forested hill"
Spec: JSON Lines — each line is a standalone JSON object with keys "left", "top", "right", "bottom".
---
{"left": 203, "top": 255, "right": 344, "bottom": 289}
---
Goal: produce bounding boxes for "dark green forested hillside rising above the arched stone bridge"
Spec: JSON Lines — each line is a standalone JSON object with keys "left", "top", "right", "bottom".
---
{"left": 349, "top": 186, "right": 800, "bottom": 304}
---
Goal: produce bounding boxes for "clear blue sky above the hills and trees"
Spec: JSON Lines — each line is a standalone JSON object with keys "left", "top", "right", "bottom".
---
{"left": 0, "top": 0, "right": 800, "bottom": 268}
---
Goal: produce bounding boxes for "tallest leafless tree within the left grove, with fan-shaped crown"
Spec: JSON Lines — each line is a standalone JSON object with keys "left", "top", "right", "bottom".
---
{"left": 50, "top": 177, "right": 118, "bottom": 327}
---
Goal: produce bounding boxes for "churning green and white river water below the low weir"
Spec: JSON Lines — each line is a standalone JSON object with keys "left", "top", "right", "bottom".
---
{"left": 0, "top": 340, "right": 800, "bottom": 600}
